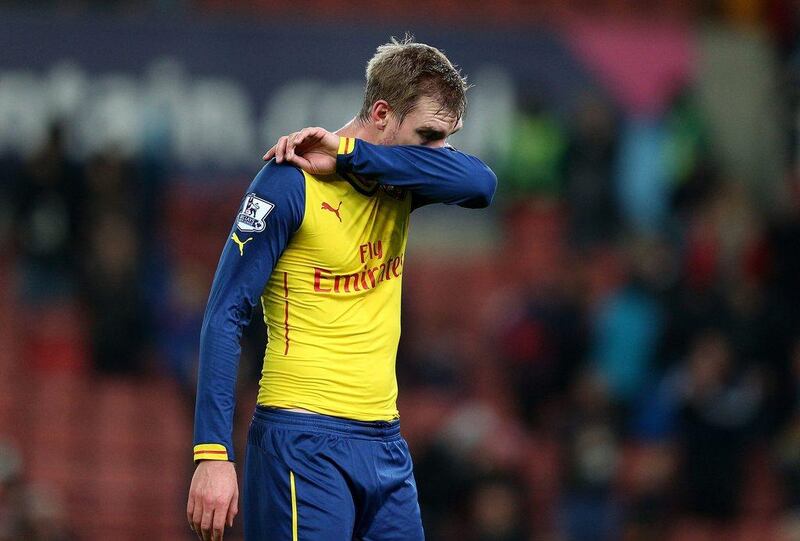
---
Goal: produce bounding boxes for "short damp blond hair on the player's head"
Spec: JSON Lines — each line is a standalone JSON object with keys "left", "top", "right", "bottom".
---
{"left": 358, "top": 34, "right": 469, "bottom": 122}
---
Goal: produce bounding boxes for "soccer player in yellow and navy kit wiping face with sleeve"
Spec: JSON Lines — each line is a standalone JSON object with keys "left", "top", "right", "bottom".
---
{"left": 187, "top": 39, "right": 497, "bottom": 541}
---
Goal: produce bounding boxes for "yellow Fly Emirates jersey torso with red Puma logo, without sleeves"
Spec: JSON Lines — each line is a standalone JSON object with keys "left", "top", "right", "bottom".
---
{"left": 258, "top": 173, "right": 411, "bottom": 421}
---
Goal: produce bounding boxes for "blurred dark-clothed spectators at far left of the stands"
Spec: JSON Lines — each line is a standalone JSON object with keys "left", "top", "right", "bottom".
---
{"left": 0, "top": 125, "right": 160, "bottom": 373}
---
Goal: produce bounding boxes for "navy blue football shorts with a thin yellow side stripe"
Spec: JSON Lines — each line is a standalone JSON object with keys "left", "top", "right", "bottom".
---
{"left": 242, "top": 406, "right": 425, "bottom": 541}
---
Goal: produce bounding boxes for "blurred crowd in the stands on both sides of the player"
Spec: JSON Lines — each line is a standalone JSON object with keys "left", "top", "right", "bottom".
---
{"left": 0, "top": 1, "right": 800, "bottom": 541}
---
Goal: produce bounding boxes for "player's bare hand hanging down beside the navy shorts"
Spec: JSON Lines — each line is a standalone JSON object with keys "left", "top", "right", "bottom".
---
{"left": 186, "top": 460, "right": 239, "bottom": 541}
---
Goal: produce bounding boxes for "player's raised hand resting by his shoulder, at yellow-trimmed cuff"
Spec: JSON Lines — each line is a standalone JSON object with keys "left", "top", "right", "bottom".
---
{"left": 263, "top": 128, "right": 339, "bottom": 175}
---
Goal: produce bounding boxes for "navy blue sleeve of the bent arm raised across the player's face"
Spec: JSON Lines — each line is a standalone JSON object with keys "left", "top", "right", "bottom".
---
{"left": 336, "top": 139, "right": 497, "bottom": 208}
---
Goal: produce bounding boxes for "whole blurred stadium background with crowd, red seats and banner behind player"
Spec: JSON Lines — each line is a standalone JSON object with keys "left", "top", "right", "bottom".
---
{"left": 0, "top": 0, "right": 800, "bottom": 541}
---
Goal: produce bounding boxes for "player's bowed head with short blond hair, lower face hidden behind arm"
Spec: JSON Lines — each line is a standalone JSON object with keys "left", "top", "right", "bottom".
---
{"left": 358, "top": 35, "right": 468, "bottom": 146}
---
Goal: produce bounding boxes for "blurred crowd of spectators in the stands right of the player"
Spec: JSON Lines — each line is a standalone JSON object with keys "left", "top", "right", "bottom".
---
{"left": 398, "top": 99, "right": 800, "bottom": 540}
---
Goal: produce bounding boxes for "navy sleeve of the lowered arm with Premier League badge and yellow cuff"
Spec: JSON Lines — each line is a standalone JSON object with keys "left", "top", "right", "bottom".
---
{"left": 194, "top": 161, "right": 305, "bottom": 460}
